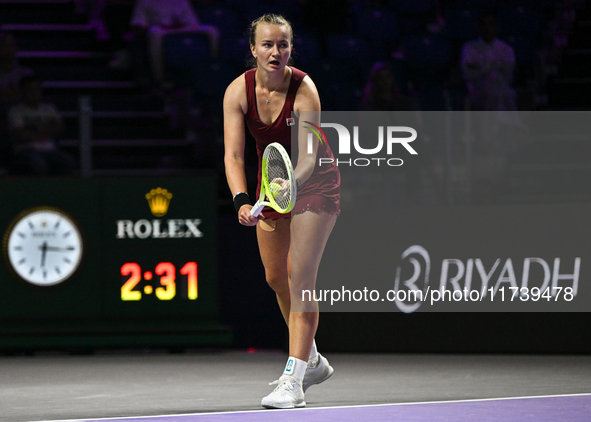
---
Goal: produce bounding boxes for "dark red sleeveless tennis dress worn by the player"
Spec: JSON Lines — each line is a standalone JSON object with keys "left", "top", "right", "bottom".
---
{"left": 244, "top": 67, "right": 341, "bottom": 220}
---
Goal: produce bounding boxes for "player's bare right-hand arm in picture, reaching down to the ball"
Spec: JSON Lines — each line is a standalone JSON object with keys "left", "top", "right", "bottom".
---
{"left": 294, "top": 76, "right": 320, "bottom": 186}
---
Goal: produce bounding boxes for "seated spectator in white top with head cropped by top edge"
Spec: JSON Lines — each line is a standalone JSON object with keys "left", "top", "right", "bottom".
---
{"left": 131, "top": 0, "right": 220, "bottom": 84}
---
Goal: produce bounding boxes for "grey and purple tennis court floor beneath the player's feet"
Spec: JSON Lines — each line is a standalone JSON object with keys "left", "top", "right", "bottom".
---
{"left": 0, "top": 351, "right": 591, "bottom": 422}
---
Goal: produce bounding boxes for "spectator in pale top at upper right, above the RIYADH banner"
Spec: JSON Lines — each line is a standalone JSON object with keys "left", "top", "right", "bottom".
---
{"left": 461, "top": 12, "right": 516, "bottom": 111}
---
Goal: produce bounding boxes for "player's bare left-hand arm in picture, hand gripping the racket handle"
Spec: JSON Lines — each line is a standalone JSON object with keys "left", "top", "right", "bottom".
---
{"left": 224, "top": 76, "right": 258, "bottom": 226}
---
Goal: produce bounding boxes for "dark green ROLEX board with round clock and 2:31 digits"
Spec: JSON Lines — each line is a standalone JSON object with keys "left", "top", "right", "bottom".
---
{"left": 0, "top": 177, "right": 230, "bottom": 350}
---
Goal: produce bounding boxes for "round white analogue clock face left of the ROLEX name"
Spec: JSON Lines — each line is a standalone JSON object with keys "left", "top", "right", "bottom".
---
{"left": 5, "top": 209, "right": 83, "bottom": 286}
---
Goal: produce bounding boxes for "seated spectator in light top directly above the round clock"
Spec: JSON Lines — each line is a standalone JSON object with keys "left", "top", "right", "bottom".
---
{"left": 8, "top": 76, "right": 75, "bottom": 176}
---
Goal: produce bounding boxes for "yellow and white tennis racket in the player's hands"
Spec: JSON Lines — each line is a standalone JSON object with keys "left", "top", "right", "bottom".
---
{"left": 250, "top": 142, "right": 297, "bottom": 217}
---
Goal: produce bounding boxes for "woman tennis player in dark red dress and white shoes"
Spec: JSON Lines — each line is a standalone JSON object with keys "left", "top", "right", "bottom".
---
{"left": 224, "top": 14, "right": 340, "bottom": 409}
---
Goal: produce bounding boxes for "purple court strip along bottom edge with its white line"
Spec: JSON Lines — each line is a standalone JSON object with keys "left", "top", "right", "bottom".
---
{"left": 35, "top": 393, "right": 591, "bottom": 422}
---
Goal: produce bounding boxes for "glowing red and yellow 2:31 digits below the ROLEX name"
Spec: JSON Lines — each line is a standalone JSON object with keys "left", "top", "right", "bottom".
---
{"left": 121, "top": 262, "right": 198, "bottom": 301}
